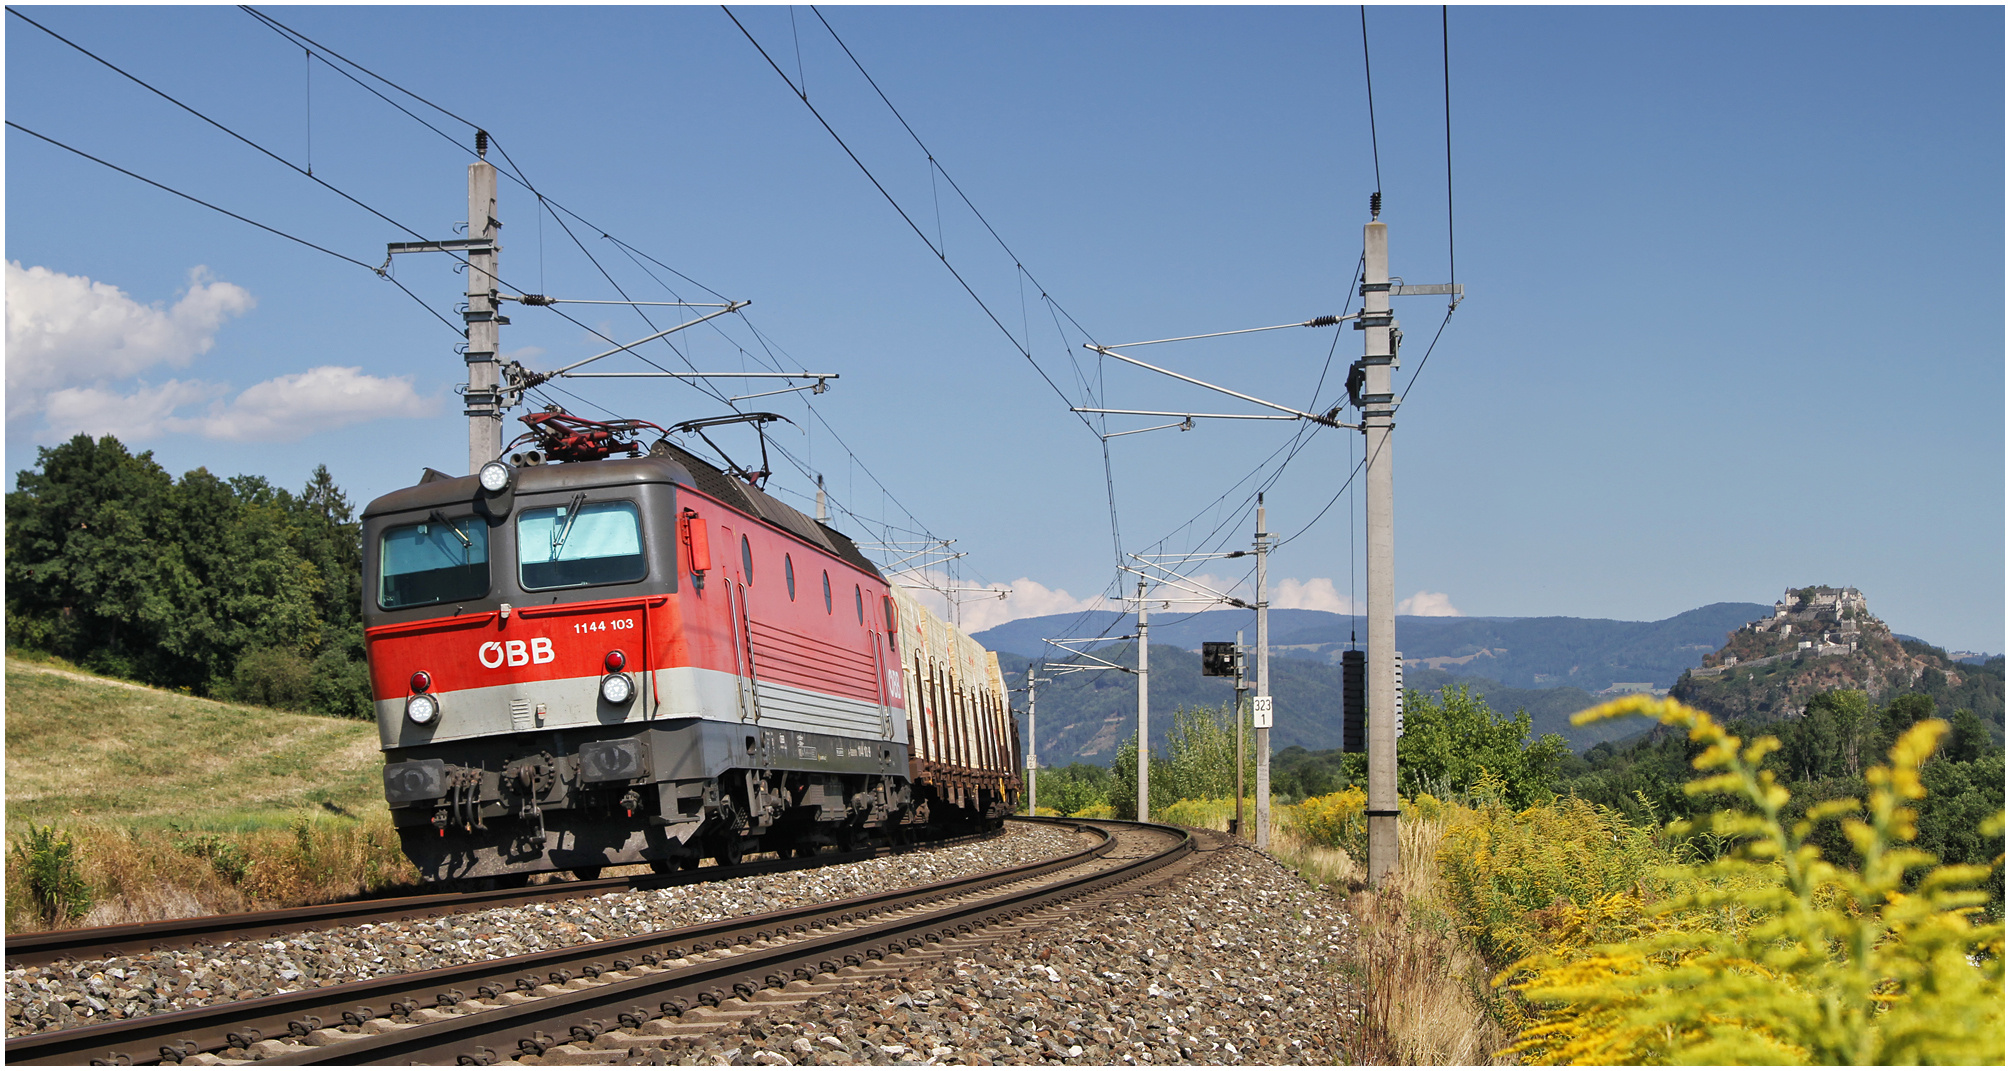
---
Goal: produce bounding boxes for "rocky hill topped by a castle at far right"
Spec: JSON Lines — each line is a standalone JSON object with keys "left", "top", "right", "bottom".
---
{"left": 1670, "top": 587, "right": 2004, "bottom": 739}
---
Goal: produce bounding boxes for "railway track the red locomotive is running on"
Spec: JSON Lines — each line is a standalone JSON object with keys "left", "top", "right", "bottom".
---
{"left": 6, "top": 819, "right": 999, "bottom": 967}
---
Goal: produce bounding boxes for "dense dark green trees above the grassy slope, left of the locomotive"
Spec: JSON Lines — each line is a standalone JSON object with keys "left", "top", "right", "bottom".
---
{"left": 6, "top": 436, "right": 370, "bottom": 717}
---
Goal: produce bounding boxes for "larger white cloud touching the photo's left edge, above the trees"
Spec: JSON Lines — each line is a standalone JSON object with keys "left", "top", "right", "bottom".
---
{"left": 6, "top": 261, "right": 257, "bottom": 420}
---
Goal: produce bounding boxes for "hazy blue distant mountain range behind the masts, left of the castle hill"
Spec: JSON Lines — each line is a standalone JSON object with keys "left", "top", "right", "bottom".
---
{"left": 975, "top": 603, "right": 1773, "bottom": 766}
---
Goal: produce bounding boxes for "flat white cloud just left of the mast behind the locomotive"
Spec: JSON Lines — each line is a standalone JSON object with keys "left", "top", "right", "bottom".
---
{"left": 167, "top": 364, "right": 438, "bottom": 442}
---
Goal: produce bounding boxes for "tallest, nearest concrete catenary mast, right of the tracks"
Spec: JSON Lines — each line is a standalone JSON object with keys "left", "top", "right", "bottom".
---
{"left": 1359, "top": 208, "right": 1397, "bottom": 886}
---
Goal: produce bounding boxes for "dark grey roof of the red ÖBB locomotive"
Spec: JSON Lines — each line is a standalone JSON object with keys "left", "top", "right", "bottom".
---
{"left": 364, "top": 442, "right": 880, "bottom": 577}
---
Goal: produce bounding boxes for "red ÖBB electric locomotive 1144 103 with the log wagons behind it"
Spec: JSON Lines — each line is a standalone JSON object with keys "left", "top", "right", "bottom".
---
{"left": 364, "top": 412, "right": 1021, "bottom": 880}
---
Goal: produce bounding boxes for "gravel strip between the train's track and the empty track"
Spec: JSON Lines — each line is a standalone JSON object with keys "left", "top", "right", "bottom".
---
{"left": 6, "top": 822, "right": 1083, "bottom": 1037}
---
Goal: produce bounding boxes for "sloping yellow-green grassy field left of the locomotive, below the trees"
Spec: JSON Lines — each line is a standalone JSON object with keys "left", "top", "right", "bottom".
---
{"left": 6, "top": 657, "right": 416, "bottom": 932}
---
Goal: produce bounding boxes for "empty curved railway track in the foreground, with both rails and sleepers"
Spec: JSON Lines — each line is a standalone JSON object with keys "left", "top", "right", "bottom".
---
{"left": 6, "top": 822, "right": 1194, "bottom": 1063}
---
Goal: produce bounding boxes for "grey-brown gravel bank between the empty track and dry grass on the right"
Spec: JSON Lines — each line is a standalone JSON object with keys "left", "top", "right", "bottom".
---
{"left": 629, "top": 844, "right": 1361, "bottom": 1065}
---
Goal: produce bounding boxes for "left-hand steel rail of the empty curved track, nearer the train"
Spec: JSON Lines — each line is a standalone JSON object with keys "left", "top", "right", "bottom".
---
{"left": 6, "top": 822, "right": 1116, "bottom": 1065}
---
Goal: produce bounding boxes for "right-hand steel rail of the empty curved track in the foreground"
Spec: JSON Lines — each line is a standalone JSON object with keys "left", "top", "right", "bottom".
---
{"left": 283, "top": 822, "right": 1194, "bottom": 1065}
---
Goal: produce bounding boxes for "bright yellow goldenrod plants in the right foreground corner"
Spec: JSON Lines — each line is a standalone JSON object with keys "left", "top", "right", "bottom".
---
{"left": 1510, "top": 697, "right": 2004, "bottom": 1063}
